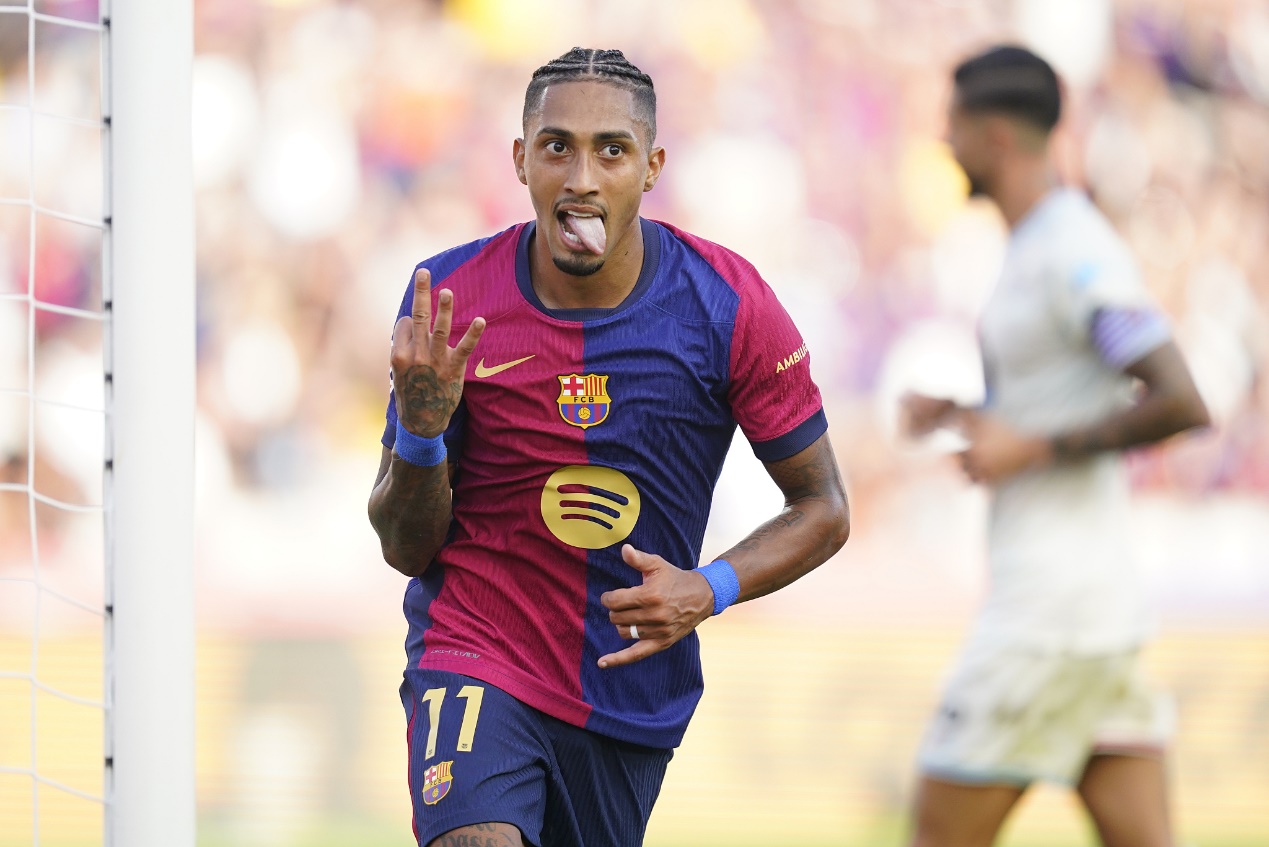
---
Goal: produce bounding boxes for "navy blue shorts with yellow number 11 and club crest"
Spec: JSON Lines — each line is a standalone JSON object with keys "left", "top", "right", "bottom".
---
{"left": 401, "top": 669, "right": 674, "bottom": 847}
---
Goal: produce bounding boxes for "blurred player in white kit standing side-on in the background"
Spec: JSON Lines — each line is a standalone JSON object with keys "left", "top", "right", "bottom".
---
{"left": 904, "top": 47, "right": 1208, "bottom": 847}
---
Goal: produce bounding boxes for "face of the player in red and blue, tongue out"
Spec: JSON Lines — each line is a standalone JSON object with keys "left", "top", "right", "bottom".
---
{"left": 513, "top": 80, "right": 665, "bottom": 277}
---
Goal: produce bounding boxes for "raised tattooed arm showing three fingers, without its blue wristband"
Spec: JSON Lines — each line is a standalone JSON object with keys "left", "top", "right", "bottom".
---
{"left": 368, "top": 268, "right": 485, "bottom": 577}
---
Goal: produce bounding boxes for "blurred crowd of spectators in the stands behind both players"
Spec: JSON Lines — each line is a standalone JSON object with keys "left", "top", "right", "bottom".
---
{"left": 0, "top": 0, "right": 1269, "bottom": 622}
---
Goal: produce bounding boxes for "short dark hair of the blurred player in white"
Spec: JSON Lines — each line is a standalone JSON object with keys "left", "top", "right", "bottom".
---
{"left": 954, "top": 46, "right": 1062, "bottom": 132}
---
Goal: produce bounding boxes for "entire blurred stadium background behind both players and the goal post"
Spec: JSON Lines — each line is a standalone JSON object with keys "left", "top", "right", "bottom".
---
{"left": 0, "top": 0, "right": 1269, "bottom": 847}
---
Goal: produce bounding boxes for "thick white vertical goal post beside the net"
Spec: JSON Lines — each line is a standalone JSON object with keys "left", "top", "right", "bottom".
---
{"left": 102, "top": 0, "right": 195, "bottom": 847}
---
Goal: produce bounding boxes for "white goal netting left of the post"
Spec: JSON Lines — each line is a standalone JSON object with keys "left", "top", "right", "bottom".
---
{"left": 0, "top": 0, "right": 108, "bottom": 847}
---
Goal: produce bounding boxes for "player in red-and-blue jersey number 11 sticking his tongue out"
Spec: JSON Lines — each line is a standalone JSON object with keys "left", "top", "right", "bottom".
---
{"left": 369, "top": 48, "right": 849, "bottom": 847}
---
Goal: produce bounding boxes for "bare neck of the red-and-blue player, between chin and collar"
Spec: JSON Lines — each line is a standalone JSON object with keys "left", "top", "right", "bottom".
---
{"left": 529, "top": 217, "right": 643, "bottom": 309}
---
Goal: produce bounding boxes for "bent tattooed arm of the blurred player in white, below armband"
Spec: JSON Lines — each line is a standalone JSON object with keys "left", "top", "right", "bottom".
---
{"left": 961, "top": 342, "right": 1211, "bottom": 483}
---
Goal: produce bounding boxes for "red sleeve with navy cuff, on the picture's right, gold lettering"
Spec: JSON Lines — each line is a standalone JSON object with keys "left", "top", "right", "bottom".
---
{"left": 727, "top": 273, "right": 829, "bottom": 462}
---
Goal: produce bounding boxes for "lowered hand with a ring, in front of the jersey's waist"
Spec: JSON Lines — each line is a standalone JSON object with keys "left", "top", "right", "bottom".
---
{"left": 599, "top": 544, "right": 713, "bottom": 668}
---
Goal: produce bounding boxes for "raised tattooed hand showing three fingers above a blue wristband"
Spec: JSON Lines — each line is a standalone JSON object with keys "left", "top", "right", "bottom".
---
{"left": 392, "top": 268, "right": 485, "bottom": 438}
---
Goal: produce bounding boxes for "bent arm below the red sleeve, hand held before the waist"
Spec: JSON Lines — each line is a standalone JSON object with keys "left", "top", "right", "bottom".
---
{"left": 599, "top": 433, "right": 850, "bottom": 668}
